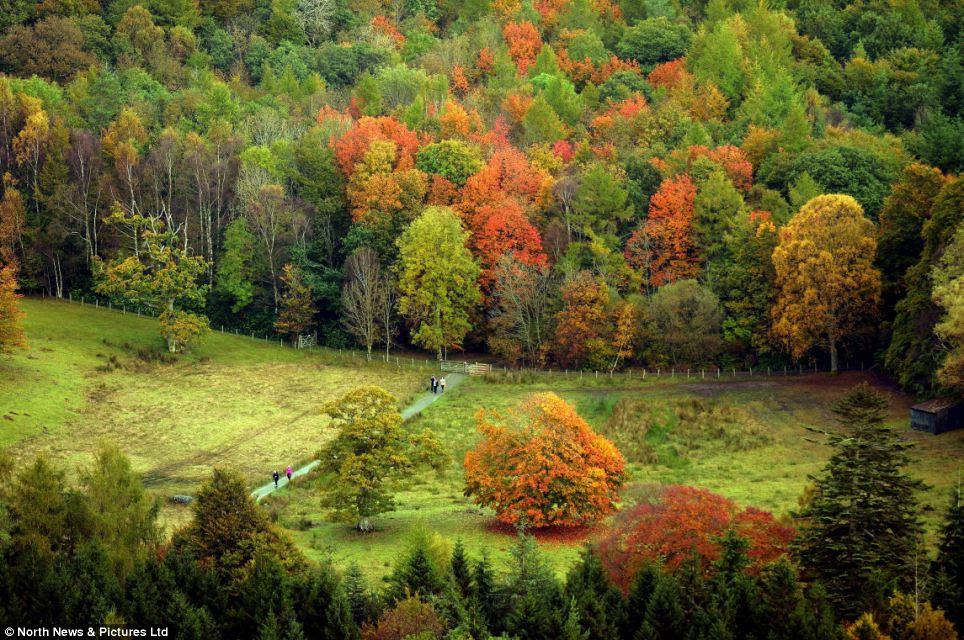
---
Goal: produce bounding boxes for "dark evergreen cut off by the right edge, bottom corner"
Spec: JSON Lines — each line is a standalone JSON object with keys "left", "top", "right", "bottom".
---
{"left": 932, "top": 482, "right": 964, "bottom": 628}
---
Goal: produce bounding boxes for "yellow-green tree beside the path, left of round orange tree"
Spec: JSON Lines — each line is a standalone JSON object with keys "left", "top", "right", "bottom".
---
{"left": 320, "top": 386, "right": 448, "bottom": 531}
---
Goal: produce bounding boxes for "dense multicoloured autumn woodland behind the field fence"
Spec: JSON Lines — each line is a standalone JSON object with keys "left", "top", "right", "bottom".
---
{"left": 0, "top": 0, "right": 964, "bottom": 393}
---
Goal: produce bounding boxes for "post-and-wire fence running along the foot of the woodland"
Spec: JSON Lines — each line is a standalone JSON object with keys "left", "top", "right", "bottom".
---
{"left": 43, "top": 293, "right": 873, "bottom": 384}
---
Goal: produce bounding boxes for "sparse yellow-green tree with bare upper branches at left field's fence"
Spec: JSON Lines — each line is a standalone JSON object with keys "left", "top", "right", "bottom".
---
{"left": 93, "top": 207, "right": 208, "bottom": 353}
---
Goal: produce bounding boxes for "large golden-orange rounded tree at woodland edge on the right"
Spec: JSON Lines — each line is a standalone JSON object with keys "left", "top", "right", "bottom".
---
{"left": 772, "top": 195, "right": 880, "bottom": 372}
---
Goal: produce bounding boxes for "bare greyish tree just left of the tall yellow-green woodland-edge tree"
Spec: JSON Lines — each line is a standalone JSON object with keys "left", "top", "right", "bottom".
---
{"left": 341, "top": 247, "right": 395, "bottom": 360}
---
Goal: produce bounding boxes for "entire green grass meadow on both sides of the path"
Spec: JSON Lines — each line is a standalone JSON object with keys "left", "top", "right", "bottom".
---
{"left": 0, "top": 300, "right": 964, "bottom": 579}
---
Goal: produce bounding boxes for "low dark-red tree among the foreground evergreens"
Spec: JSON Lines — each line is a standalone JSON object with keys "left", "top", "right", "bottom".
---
{"left": 597, "top": 485, "right": 795, "bottom": 590}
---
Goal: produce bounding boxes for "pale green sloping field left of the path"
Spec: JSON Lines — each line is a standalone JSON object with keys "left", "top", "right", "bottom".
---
{"left": 0, "top": 299, "right": 424, "bottom": 521}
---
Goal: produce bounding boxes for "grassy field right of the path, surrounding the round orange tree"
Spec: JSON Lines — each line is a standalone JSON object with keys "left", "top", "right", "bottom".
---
{"left": 269, "top": 374, "right": 964, "bottom": 579}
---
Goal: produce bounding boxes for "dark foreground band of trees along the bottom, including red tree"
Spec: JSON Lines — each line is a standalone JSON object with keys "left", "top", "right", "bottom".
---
{"left": 0, "top": 387, "right": 964, "bottom": 640}
